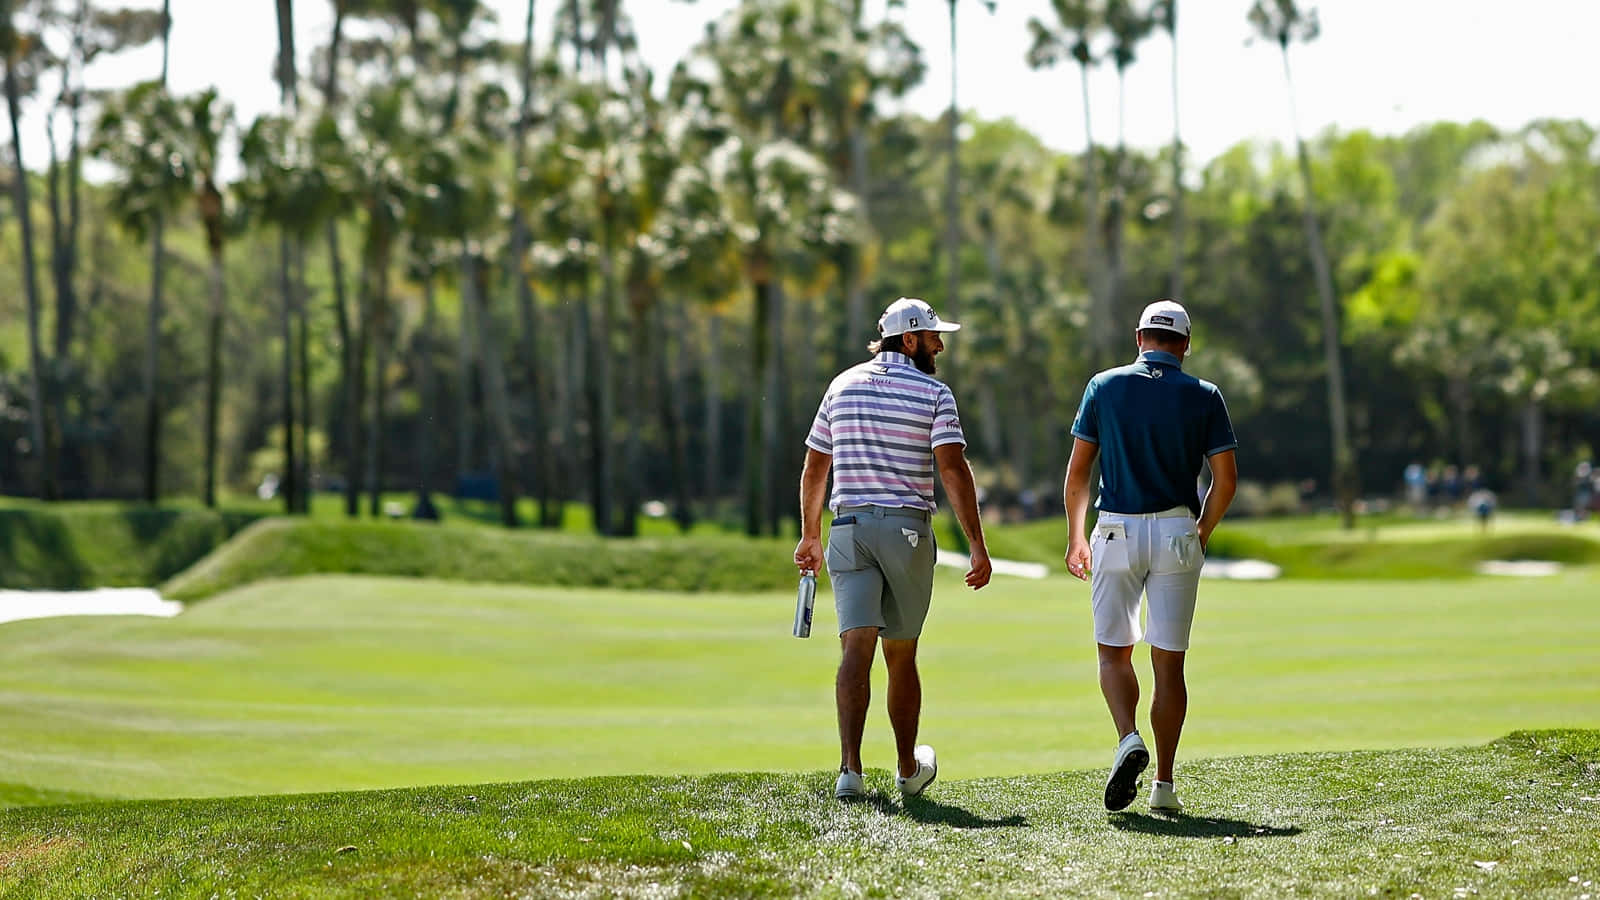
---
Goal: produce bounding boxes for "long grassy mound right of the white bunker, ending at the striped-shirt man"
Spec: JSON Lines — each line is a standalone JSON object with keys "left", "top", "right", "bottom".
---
{"left": 162, "top": 519, "right": 794, "bottom": 601}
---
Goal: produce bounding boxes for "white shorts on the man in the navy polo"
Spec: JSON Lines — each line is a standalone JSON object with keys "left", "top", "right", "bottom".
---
{"left": 1090, "top": 506, "right": 1205, "bottom": 650}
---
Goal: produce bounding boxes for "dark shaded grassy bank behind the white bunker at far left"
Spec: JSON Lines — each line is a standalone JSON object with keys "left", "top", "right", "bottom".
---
{"left": 0, "top": 501, "right": 261, "bottom": 591}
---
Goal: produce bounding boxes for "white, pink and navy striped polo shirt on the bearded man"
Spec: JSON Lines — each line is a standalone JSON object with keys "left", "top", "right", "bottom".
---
{"left": 805, "top": 352, "right": 966, "bottom": 512}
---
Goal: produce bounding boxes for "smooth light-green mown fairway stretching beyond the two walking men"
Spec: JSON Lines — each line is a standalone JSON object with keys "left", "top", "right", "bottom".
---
{"left": 0, "top": 570, "right": 1600, "bottom": 804}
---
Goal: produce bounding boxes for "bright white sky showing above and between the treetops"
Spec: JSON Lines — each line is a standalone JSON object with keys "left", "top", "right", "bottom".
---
{"left": 22, "top": 0, "right": 1600, "bottom": 175}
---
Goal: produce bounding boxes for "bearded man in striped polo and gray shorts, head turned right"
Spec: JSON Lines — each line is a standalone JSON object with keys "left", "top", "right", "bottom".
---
{"left": 795, "top": 298, "right": 989, "bottom": 799}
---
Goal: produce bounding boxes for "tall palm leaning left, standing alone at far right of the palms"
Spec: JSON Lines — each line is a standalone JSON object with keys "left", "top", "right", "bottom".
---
{"left": 1250, "top": 0, "right": 1360, "bottom": 528}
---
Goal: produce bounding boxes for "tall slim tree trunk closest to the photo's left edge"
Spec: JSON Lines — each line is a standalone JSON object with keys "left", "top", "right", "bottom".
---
{"left": 0, "top": 2, "right": 59, "bottom": 500}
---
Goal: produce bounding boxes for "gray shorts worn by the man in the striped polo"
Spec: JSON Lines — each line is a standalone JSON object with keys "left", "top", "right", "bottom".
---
{"left": 827, "top": 506, "right": 938, "bottom": 641}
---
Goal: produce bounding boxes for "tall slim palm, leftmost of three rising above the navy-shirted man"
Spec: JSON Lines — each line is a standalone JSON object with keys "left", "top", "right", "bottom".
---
{"left": 1027, "top": 0, "right": 1115, "bottom": 365}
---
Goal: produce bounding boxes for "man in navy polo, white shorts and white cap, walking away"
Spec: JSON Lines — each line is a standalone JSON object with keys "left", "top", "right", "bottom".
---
{"left": 1064, "top": 299, "right": 1238, "bottom": 810}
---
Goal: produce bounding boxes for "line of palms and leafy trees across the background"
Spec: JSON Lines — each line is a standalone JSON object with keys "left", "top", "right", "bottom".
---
{"left": 0, "top": 0, "right": 1600, "bottom": 535}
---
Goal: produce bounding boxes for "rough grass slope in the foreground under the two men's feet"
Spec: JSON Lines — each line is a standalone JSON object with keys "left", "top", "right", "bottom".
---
{"left": 0, "top": 730, "right": 1600, "bottom": 900}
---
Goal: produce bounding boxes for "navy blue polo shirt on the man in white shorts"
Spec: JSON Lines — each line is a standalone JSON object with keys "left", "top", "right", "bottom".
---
{"left": 1072, "top": 351, "right": 1238, "bottom": 517}
